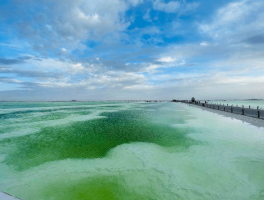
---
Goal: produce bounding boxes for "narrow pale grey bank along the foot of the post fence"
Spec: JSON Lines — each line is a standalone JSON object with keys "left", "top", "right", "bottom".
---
{"left": 190, "top": 104, "right": 264, "bottom": 128}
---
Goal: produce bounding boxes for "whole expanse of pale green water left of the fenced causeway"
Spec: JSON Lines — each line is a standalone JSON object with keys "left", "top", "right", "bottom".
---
{"left": 0, "top": 103, "right": 264, "bottom": 200}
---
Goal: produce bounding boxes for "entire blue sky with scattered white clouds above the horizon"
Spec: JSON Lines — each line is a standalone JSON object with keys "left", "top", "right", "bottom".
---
{"left": 0, "top": 0, "right": 264, "bottom": 101}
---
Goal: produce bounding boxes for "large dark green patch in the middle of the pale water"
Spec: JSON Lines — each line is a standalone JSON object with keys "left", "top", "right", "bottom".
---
{"left": 3, "top": 111, "right": 195, "bottom": 170}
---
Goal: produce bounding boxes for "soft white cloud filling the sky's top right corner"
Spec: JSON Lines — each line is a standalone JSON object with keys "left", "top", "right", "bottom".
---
{"left": 199, "top": 0, "right": 264, "bottom": 42}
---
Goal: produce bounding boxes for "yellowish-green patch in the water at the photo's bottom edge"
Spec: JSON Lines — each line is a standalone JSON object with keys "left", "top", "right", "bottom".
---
{"left": 8, "top": 172, "right": 165, "bottom": 200}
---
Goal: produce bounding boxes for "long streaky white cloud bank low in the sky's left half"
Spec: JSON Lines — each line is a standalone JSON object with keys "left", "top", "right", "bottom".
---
{"left": 0, "top": 58, "right": 153, "bottom": 92}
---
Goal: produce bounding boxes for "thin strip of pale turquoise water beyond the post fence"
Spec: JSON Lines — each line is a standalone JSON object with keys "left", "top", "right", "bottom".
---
{"left": 209, "top": 100, "right": 264, "bottom": 110}
